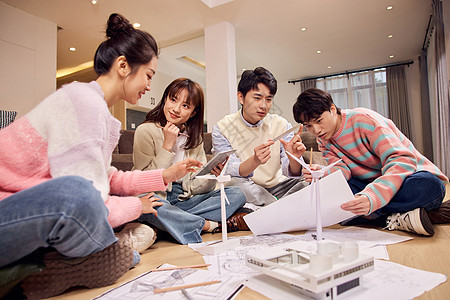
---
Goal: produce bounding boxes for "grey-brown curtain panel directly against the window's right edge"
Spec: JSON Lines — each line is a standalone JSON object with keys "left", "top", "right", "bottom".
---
{"left": 386, "top": 65, "right": 414, "bottom": 142}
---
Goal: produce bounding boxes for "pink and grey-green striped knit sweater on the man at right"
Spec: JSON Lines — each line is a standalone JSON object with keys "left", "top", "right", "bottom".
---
{"left": 318, "top": 108, "right": 448, "bottom": 213}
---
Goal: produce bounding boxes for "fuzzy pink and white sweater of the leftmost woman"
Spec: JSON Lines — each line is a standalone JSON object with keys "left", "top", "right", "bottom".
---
{"left": 0, "top": 81, "right": 167, "bottom": 227}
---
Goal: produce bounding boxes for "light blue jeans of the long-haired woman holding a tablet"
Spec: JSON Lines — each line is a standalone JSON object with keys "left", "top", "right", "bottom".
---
{"left": 139, "top": 183, "right": 245, "bottom": 244}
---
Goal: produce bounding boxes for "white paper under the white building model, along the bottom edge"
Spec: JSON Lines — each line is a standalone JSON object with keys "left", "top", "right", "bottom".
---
{"left": 245, "top": 260, "right": 447, "bottom": 300}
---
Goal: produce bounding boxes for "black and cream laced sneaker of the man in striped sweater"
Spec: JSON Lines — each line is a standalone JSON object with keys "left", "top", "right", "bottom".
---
{"left": 383, "top": 208, "right": 434, "bottom": 236}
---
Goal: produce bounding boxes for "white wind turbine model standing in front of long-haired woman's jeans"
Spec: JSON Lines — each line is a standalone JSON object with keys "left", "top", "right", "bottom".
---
{"left": 196, "top": 160, "right": 240, "bottom": 255}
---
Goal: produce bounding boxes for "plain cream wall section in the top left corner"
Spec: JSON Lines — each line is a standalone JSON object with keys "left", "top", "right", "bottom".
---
{"left": 0, "top": 2, "right": 57, "bottom": 117}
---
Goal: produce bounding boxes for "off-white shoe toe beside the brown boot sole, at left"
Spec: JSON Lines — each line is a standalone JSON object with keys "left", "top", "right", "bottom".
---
{"left": 116, "top": 223, "right": 156, "bottom": 253}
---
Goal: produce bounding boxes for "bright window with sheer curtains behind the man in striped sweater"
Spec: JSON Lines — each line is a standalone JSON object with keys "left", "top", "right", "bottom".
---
{"left": 316, "top": 68, "right": 388, "bottom": 117}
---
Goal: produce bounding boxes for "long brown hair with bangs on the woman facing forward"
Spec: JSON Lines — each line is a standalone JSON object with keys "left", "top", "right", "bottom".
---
{"left": 143, "top": 78, "right": 205, "bottom": 150}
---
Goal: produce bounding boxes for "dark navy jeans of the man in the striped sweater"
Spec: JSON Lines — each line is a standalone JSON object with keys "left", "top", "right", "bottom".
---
{"left": 345, "top": 171, "right": 445, "bottom": 226}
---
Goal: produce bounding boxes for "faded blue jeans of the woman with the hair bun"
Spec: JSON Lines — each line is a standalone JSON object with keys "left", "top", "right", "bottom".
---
{"left": 0, "top": 176, "right": 117, "bottom": 267}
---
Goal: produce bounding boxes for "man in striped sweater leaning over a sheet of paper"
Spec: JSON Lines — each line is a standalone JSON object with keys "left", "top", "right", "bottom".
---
{"left": 293, "top": 89, "right": 450, "bottom": 236}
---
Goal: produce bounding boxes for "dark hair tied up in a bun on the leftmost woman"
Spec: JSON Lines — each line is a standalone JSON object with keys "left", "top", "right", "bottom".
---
{"left": 94, "top": 13, "right": 159, "bottom": 76}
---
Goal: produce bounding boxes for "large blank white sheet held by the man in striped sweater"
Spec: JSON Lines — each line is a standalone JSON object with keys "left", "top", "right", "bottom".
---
{"left": 244, "top": 171, "right": 354, "bottom": 234}
